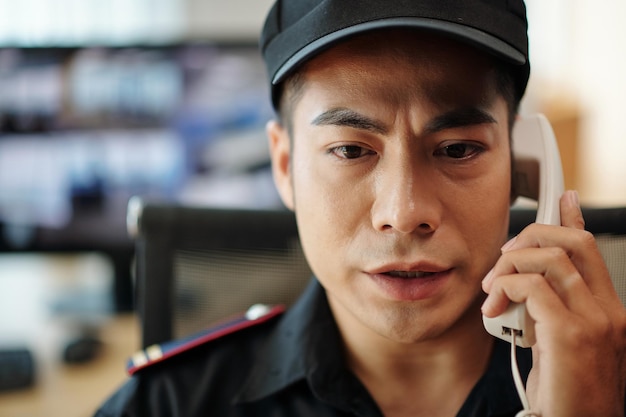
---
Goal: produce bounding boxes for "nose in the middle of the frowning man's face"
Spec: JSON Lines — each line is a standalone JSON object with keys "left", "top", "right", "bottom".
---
{"left": 372, "top": 158, "right": 441, "bottom": 234}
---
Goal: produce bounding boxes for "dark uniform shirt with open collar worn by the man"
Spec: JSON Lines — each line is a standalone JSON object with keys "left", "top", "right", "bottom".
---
{"left": 96, "top": 280, "right": 531, "bottom": 417}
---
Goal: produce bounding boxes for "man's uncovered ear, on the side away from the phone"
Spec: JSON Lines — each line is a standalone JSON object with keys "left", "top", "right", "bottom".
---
{"left": 265, "top": 120, "right": 294, "bottom": 210}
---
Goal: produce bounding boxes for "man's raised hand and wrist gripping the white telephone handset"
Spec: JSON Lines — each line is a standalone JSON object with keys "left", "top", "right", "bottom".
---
{"left": 483, "top": 191, "right": 626, "bottom": 417}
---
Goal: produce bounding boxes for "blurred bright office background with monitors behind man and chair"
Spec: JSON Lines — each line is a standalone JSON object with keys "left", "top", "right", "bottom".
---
{"left": 0, "top": 0, "right": 626, "bottom": 416}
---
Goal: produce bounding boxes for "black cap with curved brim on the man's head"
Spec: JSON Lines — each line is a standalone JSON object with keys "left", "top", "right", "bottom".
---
{"left": 261, "top": 0, "right": 530, "bottom": 107}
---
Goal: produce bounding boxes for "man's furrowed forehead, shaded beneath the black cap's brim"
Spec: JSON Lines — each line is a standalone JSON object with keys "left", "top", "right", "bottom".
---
{"left": 301, "top": 31, "right": 497, "bottom": 108}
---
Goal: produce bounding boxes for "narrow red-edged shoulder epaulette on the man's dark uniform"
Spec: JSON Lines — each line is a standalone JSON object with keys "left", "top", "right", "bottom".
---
{"left": 126, "top": 304, "right": 285, "bottom": 375}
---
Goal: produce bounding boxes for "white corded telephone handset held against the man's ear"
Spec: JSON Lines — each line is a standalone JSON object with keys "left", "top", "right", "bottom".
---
{"left": 483, "top": 114, "right": 564, "bottom": 347}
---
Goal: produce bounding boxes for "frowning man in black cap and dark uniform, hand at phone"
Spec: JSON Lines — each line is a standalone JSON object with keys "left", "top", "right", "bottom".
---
{"left": 98, "top": 0, "right": 626, "bottom": 417}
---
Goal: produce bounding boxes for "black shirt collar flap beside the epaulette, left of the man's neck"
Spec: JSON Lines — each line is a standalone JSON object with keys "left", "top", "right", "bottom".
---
{"left": 234, "top": 278, "right": 377, "bottom": 415}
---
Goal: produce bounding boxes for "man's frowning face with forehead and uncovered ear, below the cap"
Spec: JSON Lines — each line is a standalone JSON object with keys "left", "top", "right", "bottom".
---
{"left": 269, "top": 33, "right": 511, "bottom": 342}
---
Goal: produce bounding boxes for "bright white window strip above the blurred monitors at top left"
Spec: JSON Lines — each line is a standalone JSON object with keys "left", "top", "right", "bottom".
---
{"left": 0, "top": 0, "right": 185, "bottom": 47}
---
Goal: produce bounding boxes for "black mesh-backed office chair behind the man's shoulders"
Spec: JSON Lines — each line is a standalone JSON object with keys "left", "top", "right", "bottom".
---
{"left": 128, "top": 198, "right": 626, "bottom": 347}
